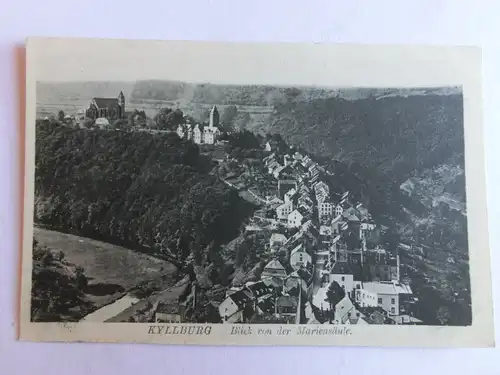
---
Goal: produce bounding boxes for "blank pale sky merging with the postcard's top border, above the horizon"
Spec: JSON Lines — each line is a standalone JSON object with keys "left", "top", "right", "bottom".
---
{"left": 27, "top": 38, "right": 472, "bottom": 87}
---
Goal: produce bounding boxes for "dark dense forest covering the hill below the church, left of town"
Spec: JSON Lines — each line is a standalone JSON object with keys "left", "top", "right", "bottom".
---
{"left": 34, "top": 120, "right": 254, "bottom": 264}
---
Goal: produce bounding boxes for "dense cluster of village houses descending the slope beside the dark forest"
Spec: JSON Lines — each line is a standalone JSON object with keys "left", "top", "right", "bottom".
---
{"left": 219, "top": 145, "right": 419, "bottom": 324}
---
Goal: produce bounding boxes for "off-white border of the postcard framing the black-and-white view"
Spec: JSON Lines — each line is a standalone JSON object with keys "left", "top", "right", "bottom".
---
{"left": 19, "top": 38, "right": 494, "bottom": 347}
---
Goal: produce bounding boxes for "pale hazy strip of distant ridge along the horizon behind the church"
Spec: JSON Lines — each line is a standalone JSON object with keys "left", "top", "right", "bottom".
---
{"left": 37, "top": 80, "right": 461, "bottom": 107}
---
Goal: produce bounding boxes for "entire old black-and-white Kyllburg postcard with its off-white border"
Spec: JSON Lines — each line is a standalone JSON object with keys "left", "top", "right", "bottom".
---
{"left": 20, "top": 38, "right": 494, "bottom": 347}
